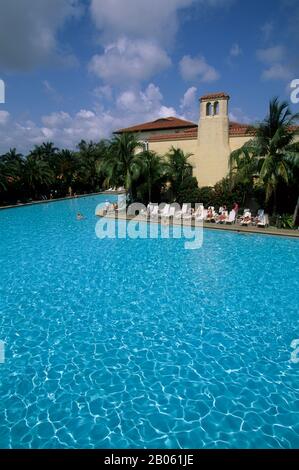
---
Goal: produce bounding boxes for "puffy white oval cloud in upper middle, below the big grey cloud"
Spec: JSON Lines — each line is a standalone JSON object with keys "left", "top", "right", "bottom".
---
{"left": 89, "top": 38, "right": 171, "bottom": 84}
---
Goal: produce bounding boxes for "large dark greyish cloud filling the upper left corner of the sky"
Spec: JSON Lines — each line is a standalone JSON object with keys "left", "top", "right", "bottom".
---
{"left": 0, "top": 0, "right": 81, "bottom": 70}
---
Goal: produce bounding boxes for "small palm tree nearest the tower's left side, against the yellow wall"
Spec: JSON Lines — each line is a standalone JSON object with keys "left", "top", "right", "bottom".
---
{"left": 166, "top": 146, "right": 192, "bottom": 195}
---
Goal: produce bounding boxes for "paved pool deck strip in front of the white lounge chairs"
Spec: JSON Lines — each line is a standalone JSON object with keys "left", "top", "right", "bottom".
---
{"left": 105, "top": 212, "right": 299, "bottom": 238}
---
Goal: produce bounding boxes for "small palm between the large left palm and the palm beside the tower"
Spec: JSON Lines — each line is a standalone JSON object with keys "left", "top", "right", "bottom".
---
{"left": 140, "top": 150, "right": 167, "bottom": 202}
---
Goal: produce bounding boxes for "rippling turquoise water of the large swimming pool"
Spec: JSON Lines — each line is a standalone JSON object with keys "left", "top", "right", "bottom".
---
{"left": 0, "top": 197, "right": 299, "bottom": 448}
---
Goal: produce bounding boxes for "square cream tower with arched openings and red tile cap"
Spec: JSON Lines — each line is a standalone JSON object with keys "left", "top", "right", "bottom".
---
{"left": 196, "top": 93, "right": 230, "bottom": 186}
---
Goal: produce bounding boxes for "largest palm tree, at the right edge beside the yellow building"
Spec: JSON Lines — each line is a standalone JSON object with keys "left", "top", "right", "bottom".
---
{"left": 230, "top": 98, "right": 299, "bottom": 213}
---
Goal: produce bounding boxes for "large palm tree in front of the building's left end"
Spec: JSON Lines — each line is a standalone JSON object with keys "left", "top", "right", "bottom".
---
{"left": 103, "top": 132, "right": 143, "bottom": 200}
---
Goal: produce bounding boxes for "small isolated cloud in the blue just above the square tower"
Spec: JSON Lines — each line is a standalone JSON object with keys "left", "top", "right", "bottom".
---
{"left": 179, "top": 55, "right": 220, "bottom": 82}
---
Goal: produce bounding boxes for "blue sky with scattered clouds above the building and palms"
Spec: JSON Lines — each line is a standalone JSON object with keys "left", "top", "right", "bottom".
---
{"left": 0, "top": 0, "right": 299, "bottom": 152}
